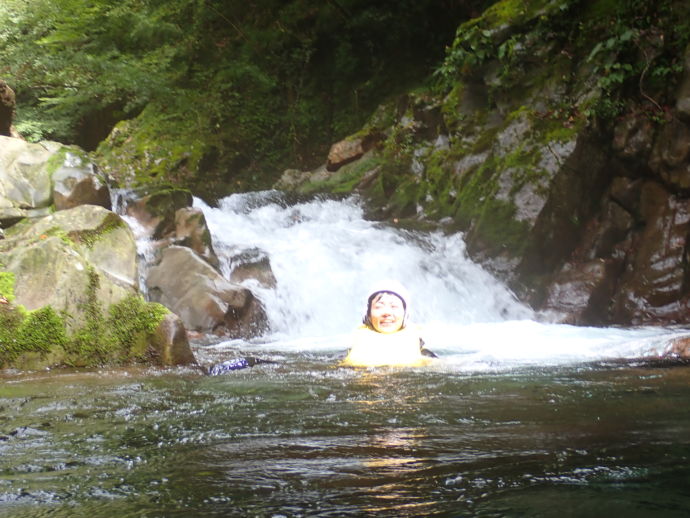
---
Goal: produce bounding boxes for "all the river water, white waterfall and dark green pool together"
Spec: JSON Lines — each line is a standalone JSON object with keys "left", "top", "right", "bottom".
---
{"left": 0, "top": 192, "right": 690, "bottom": 518}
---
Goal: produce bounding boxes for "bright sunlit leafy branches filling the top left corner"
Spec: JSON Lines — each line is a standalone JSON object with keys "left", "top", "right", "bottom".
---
{"left": 0, "top": 0, "right": 185, "bottom": 141}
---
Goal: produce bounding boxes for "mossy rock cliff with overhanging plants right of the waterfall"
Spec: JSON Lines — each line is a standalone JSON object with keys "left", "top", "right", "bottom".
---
{"left": 276, "top": 1, "right": 690, "bottom": 325}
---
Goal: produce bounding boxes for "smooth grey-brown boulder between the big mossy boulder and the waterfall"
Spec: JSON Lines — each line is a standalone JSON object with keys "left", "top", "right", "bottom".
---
{"left": 146, "top": 246, "right": 267, "bottom": 338}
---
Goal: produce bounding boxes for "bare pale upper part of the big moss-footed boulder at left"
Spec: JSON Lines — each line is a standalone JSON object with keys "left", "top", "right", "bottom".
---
{"left": 0, "top": 205, "right": 138, "bottom": 330}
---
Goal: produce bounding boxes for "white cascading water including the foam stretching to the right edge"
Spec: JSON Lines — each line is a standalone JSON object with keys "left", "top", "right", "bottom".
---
{"left": 195, "top": 191, "right": 681, "bottom": 370}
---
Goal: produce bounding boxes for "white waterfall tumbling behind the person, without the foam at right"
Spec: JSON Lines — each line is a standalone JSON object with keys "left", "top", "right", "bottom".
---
{"left": 195, "top": 191, "right": 531, "bottom": 338}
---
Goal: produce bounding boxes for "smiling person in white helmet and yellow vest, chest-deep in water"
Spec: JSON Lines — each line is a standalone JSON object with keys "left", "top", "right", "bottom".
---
{"left": 343, "top": 281, "right": 437, "bottom": 367}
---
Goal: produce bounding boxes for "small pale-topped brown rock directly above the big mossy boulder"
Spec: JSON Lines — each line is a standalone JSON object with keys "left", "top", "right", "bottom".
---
{"left": 53, "top": 152, "right": 112, "bottom": 210}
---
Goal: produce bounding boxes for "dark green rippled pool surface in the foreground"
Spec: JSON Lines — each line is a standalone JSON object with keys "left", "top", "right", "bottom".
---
{"left": 0, "top": 356, "right": 690, "bottom": 518}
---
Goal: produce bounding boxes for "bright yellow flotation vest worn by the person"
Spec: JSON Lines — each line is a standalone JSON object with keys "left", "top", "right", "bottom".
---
{"left": 343, "top": 326, "right": 431, "bottom": 367}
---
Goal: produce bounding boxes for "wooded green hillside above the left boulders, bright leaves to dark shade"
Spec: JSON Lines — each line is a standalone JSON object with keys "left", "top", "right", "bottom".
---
{"left": 0, "top": 0, "right": 472, "bottom": 191}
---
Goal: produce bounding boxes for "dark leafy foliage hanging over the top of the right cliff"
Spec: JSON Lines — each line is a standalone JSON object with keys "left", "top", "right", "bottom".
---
{"left": 435, "top": 0, "right": 690, "bottom": 125}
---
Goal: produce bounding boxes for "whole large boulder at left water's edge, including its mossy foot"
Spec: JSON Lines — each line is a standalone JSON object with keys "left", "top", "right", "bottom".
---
{"left": 0, "top": 205, "right": 194, "bottom": 368}
